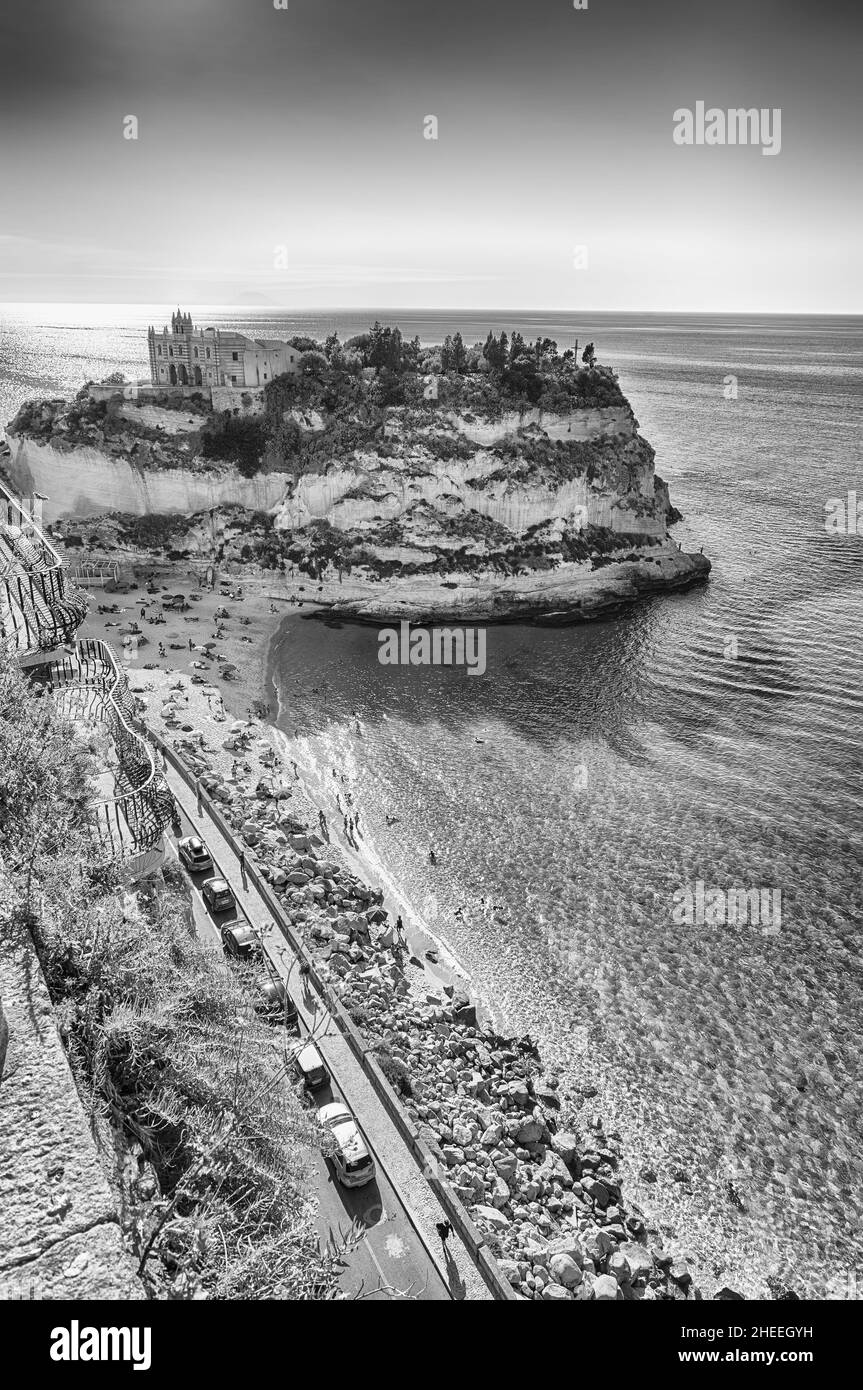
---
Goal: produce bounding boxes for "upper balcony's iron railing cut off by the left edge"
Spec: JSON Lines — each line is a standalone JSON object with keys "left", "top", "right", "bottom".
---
{"left": 0, "top": 482, "right": 89, "bottom": 655}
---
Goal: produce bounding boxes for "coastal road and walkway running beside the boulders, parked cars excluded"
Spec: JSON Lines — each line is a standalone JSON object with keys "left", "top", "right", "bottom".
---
{"left": 165, "top": 806, "right": 458, "bottom": 1301}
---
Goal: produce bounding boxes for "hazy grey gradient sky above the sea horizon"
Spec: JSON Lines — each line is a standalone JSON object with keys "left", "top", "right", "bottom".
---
{"left": 0, "top": 0, "right": 863, "bottom": 313}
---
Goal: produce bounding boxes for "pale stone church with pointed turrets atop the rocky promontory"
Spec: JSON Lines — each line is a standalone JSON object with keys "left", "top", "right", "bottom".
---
{"left": 147, "top": 309, "right": 300, "bottom": 388}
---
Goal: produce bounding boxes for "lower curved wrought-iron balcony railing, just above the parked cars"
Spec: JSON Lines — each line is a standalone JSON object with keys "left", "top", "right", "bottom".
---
{"left": 31, "top": 638, "right": 174, "bottom": 859}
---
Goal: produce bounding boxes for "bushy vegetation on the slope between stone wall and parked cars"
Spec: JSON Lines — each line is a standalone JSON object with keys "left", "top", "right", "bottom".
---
{"left": 0, "top": 663, "right": 338, "bottom": 1298}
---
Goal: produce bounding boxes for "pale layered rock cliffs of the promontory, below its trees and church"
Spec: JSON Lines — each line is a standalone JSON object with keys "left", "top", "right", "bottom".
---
{"left": 7, "top": 373, "right": 710, "bottom": 623}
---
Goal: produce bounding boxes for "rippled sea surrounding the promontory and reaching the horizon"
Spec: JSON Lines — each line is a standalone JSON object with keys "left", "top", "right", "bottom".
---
{"left": 0, "top": 306, "right": 863, "bottom": 1298}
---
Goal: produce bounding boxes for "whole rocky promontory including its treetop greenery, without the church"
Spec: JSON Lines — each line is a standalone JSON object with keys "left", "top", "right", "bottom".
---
{"left": 7, "top": 324, "right": 710, "bottom": 621}
